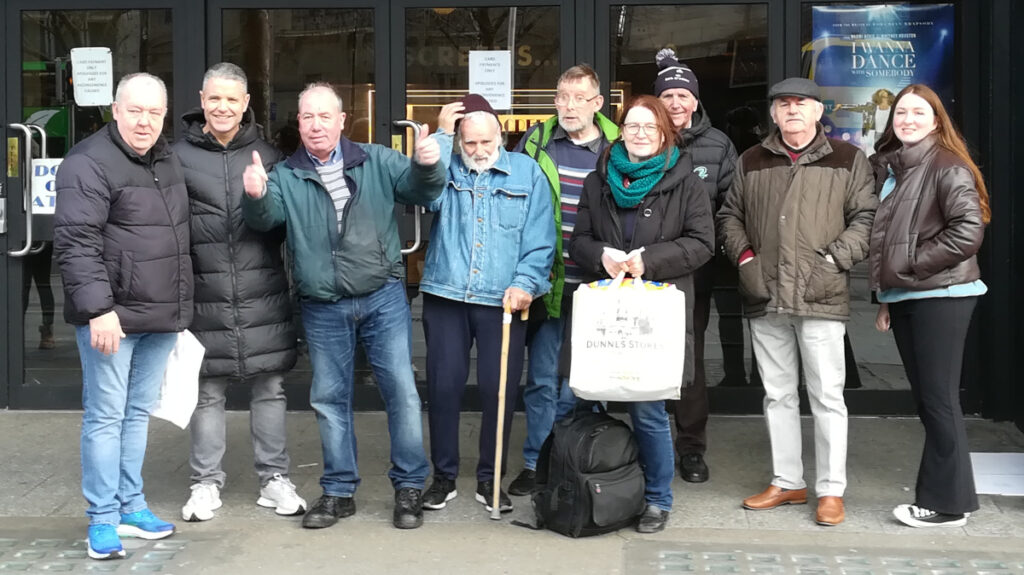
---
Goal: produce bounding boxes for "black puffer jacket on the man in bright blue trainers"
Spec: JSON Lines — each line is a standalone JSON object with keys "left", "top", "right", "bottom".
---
{"left": 53, "top": 122, "right": 193, "bottom": 334}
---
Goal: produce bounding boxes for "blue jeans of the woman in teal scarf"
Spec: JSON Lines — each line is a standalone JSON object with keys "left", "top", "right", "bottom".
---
{"left": 624, "top": 401, "right": 676, "bottom": 512}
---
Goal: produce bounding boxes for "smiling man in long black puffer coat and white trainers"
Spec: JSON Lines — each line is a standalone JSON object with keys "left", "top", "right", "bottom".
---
{"left": 174, "top": 62, "right": 306, "bottom": 521}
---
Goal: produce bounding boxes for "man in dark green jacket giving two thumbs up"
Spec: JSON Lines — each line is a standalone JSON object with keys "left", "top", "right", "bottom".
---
{"left": 243, "top": 83, "right": 446, "bottom": 529}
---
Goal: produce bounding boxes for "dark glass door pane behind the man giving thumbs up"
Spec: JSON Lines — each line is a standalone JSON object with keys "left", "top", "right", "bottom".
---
{"left": 222, "top": 8, "right": 376, "bottom": 144}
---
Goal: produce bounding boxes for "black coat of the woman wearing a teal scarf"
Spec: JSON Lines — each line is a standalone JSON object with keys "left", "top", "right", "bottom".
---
{"left": 562, "top": 143, "right": 715, "bottom": 386}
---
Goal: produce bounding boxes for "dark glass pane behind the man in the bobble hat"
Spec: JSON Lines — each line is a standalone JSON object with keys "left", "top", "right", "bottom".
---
{"left": 608, "top": 4, "right": 768, "bottom": 386}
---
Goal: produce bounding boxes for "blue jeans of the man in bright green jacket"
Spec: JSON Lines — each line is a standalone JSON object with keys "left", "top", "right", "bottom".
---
{"left": 522, "top": 317, "right": 575, "bottom": 470}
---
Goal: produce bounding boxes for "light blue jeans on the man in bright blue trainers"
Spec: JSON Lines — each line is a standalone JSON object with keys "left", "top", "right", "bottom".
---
{"left": 75, "top": 325, "right": 178, "bottom": 525}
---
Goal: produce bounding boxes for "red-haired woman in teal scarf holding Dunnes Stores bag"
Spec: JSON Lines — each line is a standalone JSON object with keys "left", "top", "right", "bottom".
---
{"left": 562, "top": 95, "right": 715, "bottom": 533}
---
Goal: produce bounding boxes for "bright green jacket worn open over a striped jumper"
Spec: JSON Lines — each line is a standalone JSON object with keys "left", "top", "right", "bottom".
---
{"left": 522, "top": 112, "right": 618, "bottom": 317}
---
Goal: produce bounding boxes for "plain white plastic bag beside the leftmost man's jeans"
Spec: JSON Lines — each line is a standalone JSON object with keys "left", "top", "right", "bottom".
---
{"left": 150, "top": 329, "right": 206, "bottom": 429}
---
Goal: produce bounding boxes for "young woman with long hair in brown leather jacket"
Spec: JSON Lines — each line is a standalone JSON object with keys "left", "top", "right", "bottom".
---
{"left": 870, "top": 84, "right": 991, "bottom": 527}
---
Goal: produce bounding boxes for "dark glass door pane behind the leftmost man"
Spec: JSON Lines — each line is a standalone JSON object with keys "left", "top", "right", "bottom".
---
{"left": 20, "top": 9, "right": 174, "bottom": 385}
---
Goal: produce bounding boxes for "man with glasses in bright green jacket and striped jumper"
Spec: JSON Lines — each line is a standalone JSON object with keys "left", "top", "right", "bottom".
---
{"left": 509, "top": 64, "right": 618, "bottom": 495}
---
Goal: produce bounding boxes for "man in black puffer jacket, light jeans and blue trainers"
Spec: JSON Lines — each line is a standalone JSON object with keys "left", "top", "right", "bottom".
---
{"left": 53, "top": 74, "right": 193, "bottom": 559}
